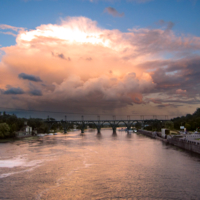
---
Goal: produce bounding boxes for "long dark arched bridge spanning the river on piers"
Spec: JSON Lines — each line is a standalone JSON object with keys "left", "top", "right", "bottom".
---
{"left": 45, "top": 116, "right": 168, "bottom": 134}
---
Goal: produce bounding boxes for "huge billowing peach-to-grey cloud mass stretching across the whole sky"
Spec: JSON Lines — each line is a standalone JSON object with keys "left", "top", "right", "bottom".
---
{"left": 0, "top": 17, "right": 200, "bottom": 115}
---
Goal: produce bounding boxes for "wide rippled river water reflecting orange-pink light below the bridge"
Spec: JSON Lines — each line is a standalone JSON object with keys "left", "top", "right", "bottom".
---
{"left": 0, "top": 129, "right": 200, "bottom": 200}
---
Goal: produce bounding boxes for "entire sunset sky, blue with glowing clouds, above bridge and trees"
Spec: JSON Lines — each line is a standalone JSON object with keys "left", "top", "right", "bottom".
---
{"left": 0, "top": 0, "right": 200, "bottom": 119}
